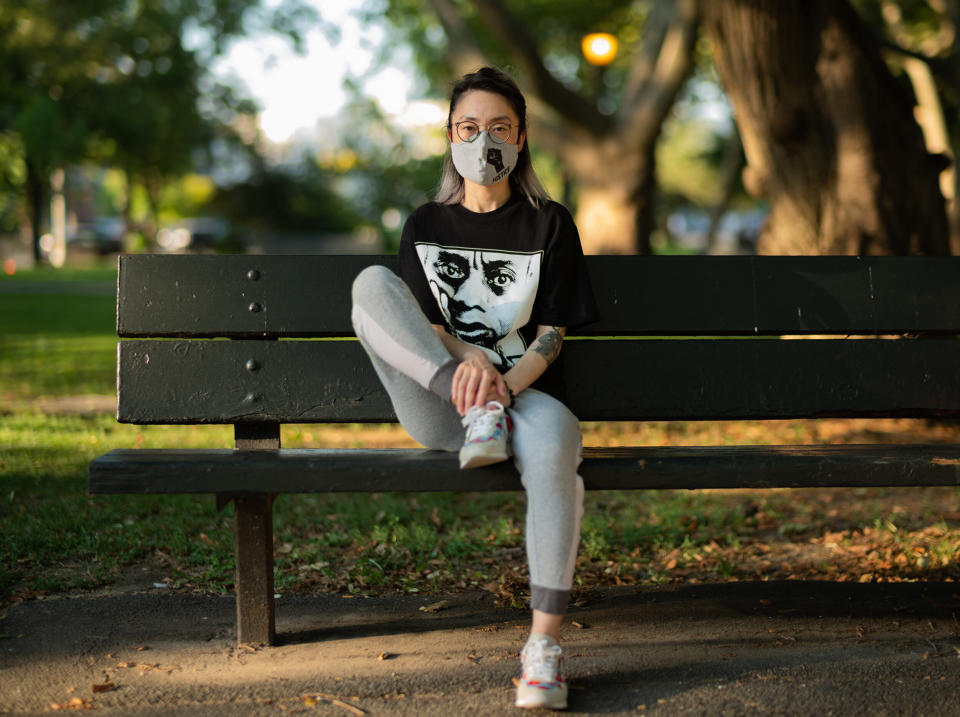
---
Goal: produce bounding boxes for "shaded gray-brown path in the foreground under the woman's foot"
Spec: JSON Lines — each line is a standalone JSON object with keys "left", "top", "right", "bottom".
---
{"left": 0, "top": 582, "right": 960, "bottom": 717}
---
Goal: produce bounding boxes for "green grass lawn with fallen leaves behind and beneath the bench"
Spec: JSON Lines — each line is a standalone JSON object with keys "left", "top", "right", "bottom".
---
{"left": 0, "top": 269, "right": 960, "bottom": 604}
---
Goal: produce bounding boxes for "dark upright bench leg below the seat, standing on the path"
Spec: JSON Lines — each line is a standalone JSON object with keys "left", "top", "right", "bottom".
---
{"left": 233, "top": 493, "right": 276, "bottom": 645}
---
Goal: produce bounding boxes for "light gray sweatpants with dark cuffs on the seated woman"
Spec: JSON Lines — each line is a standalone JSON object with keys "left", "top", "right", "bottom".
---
{"left": 352, "top": 266, "right": 583, "bottom": 615}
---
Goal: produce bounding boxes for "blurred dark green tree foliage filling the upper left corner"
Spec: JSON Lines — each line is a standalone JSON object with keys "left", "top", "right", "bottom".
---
{"left": 0, "top": 0, "right": 316, "bottom": 242}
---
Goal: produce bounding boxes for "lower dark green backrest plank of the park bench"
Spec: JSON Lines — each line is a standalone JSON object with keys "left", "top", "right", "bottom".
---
{"left": 118, "top": 338, "right": 960, "bottom": 424}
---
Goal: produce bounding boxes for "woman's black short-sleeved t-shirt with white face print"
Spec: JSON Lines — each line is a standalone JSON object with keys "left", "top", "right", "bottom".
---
{"left": 399, "top": 193, "right": 597, "bottom": 400}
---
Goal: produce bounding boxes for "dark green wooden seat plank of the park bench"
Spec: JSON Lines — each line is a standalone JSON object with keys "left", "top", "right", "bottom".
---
{"left": 90, "top": 445, "right": 960, "bottom": 494}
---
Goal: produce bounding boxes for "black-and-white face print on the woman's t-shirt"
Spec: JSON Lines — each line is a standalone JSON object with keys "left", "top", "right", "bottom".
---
{"left": 416, "top": 243, "right": 542, "bottom": 368}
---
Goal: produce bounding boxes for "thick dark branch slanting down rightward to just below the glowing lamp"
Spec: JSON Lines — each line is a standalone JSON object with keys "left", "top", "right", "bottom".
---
{"left": 476, "top": 0, "right": 613, "bottom": 136}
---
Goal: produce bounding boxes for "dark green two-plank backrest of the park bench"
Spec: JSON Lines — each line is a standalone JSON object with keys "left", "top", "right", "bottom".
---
{"left": 117, "top": 255, "right": 960, "bottom": 423}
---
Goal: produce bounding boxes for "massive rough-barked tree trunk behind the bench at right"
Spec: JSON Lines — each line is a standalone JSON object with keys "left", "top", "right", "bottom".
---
{"left": 701, "top": 0, "right": 949, "bottom": 254}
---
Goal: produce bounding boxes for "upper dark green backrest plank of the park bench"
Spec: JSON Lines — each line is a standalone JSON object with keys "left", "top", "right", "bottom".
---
{"left": 117, "top": 255, "right": 960, "bottom": 338}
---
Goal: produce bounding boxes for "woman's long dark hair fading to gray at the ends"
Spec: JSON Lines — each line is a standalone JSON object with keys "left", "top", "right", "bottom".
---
{"left": 434, "top": 67, "right": 550, "bottom": 208}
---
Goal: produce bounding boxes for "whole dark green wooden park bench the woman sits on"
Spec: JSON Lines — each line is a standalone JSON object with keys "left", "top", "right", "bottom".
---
{"left": 90, "top": 256, "right": 960, "bottom": 644}
